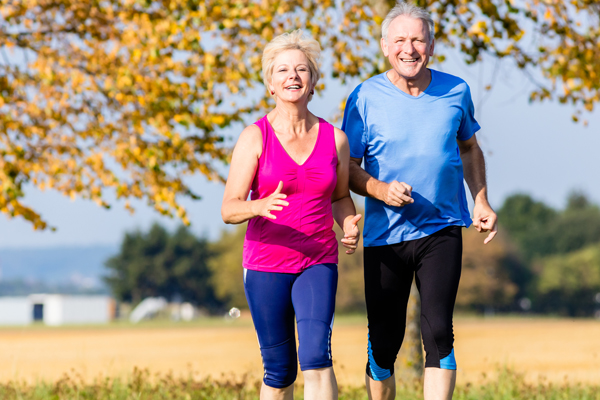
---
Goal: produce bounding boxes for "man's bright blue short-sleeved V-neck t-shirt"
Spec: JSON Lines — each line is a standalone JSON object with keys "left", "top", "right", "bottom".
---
{"left": 342, "top": 70, "right": 480, "bottom": 247}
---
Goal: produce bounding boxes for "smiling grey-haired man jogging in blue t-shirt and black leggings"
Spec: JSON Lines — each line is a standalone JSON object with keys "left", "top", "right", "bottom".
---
{"left": 342, "top": 2, "right": 496, "bottom": 400}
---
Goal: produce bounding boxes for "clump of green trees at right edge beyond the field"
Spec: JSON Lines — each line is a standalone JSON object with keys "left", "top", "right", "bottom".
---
{"left": 498, "top": 192, "right": 600, "bottom": 315}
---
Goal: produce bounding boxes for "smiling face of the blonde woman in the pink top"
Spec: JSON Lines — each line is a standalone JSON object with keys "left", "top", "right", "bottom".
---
{"left": 269, "top": 50, "right": 313, "bottom": 103}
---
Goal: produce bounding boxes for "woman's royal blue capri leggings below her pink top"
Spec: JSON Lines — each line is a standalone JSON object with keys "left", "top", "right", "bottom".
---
{"left": 244, "top": 264, "right": 338, "bottom": 389}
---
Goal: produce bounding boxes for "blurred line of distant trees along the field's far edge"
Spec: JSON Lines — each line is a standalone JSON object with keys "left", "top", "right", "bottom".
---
{"left": 106, "top": 192, "right": 600, "bottom": 316}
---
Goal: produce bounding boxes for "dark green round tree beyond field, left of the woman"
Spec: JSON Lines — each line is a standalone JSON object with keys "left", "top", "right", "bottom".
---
{"left": 105, "top": 224, "right": 221, "bottom": 310}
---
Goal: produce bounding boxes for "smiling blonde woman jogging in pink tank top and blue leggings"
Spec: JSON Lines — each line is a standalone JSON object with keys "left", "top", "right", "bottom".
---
{"left": 221, "top": 30, "right": 361, "bottom": 400}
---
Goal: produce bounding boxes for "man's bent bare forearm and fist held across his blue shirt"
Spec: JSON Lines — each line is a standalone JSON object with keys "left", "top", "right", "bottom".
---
{"left": 350, "top": 157, "right": 414, "bottom": 207}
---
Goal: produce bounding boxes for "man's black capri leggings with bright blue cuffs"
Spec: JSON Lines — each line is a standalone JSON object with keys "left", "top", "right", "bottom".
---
{"left": 364, "top": 226, "right": 462, "bottom": 381}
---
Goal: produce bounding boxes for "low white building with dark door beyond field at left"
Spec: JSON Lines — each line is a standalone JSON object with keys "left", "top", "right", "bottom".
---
{"left": 0, "top": 294, "right": 115, "bottom": 326}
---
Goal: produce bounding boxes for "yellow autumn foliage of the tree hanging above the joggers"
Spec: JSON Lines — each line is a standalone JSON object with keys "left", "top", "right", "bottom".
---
{"left": 0, "top": 0, "right": 600, "bottom": 229}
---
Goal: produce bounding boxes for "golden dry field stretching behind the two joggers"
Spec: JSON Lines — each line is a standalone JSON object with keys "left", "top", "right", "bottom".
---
{"left": 0, "top": 315, "right": 600, "bottom": 387}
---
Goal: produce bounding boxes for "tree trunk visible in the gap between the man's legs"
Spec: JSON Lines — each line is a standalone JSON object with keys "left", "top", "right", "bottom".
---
{"left": 396, "top": 281, "right": 423, "bottom": 380}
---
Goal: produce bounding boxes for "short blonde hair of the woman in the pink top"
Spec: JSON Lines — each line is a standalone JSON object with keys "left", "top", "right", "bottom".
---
{"left": 262, "top": 29, "right": 321, "bottom": 101}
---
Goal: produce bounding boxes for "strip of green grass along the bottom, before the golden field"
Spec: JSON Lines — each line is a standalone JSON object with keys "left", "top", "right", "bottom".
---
{"left": 0, "top": 369, "right": 600, "bottom": 400}
